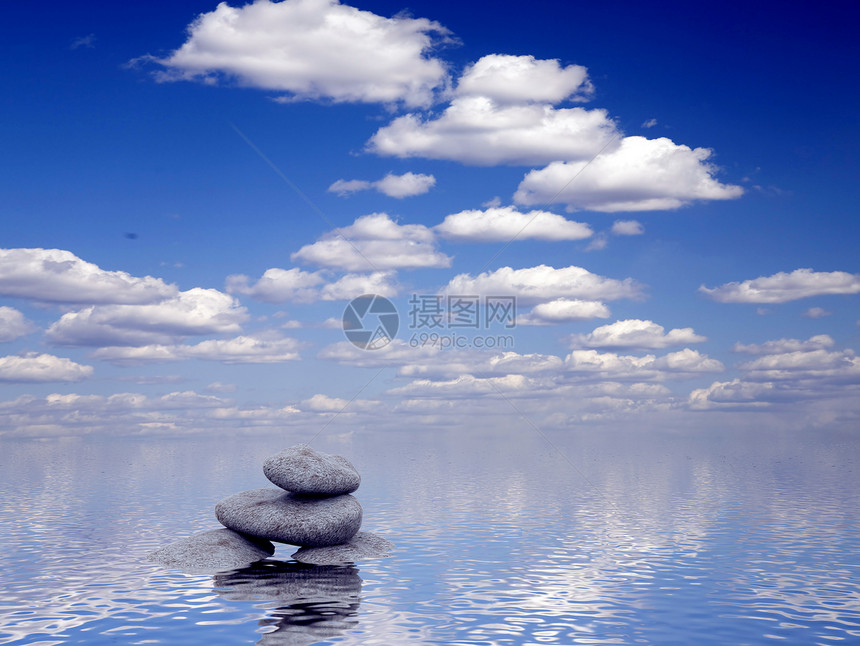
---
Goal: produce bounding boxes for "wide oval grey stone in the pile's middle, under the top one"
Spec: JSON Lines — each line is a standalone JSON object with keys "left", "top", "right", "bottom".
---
{"left": 215, "top": 488, "right": 361, "bottom": 547}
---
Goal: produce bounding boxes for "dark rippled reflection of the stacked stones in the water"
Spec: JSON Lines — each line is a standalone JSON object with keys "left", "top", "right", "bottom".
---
{"left": 214, "top": 560, "right": 362, "bottom": 646}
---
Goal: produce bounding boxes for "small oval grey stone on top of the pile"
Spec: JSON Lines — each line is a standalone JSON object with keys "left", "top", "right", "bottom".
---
{"left": 263, "top": 444, "right": 361, "bottom": 496}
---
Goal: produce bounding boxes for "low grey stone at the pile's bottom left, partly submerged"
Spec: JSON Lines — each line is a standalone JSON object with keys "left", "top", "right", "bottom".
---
{"left": 147, "top": 529, "right": 275, "bottom": 572}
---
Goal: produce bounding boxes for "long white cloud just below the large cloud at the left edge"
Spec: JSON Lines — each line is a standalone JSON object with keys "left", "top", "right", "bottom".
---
{"left": 46, "top": 287, "right": 248, "bottom": 346}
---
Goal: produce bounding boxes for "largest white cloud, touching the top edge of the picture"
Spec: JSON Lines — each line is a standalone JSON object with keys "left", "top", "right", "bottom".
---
{"left": 143, "top": 0, "right": 448, "bottom": 106}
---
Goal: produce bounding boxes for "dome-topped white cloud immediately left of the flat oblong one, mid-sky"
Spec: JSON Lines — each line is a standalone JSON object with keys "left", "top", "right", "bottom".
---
{"left": 290, "top": 213, "right": 451, "bottom": 271}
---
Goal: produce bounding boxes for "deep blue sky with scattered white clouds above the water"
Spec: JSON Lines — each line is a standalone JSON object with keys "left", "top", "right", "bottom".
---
{"left": 0, "top": 0, "right": 860, "bottom": 436}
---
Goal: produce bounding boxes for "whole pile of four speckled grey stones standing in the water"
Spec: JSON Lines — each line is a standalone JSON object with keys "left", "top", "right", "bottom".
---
{"left": 149, "top": 444, "right": 393, "bottom": 569}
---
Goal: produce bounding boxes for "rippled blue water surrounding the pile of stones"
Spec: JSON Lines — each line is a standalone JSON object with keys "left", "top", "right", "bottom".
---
{"left": 0, "top": 429, "right": 860, "bottom": 646}
